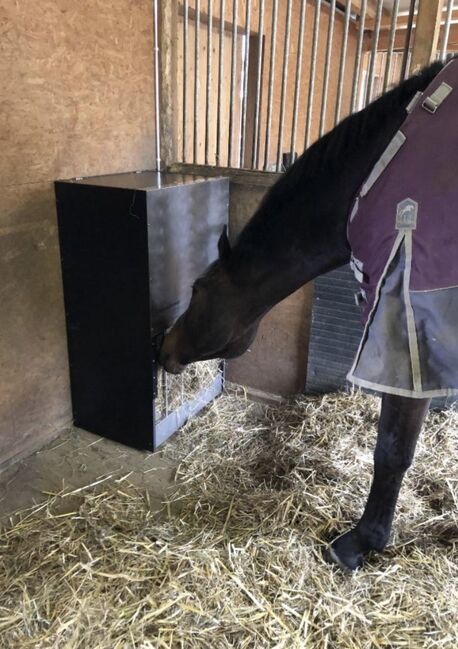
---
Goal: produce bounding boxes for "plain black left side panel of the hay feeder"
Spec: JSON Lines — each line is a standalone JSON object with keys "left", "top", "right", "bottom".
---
{"left": 55, "top": 182, "right": 153, "bottom": 448}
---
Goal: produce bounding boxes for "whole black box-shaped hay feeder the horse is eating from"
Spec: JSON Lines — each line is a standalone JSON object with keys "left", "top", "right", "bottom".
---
{"left": 55, "top": 171, "right": 229, "bottom": 449}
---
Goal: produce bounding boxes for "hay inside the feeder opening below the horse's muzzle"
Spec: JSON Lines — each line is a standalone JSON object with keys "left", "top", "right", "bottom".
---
{"left": 155, "top": 359, "right": 221, "bottom": 419}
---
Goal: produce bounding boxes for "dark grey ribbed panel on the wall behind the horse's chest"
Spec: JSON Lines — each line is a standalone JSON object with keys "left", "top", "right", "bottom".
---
{"left": 305, "top": 266, "right": 363, "bottom": 394}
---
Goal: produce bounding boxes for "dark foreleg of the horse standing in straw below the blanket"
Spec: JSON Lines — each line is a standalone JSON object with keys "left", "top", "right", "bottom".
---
{"left": 330, "top": 395, "right": 430, "bottom": 570}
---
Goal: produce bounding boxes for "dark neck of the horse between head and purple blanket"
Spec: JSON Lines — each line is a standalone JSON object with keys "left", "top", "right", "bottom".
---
{"left": 233, "top": 68, "right": 438, "bottom": 320}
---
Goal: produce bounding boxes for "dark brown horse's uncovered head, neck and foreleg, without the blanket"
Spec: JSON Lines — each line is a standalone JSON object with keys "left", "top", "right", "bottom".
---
{"left": 160, "top": 63, "right": 442, "bottom": 569}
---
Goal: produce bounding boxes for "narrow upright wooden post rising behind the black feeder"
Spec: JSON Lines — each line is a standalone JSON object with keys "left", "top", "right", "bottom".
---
{"left": 159, "top": 0, "right": 178, "bottom": 167}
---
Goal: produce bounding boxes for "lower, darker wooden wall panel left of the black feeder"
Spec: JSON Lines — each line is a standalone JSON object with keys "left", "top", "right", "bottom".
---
{"left": 0, "top": 219, "right": 70, "bottom": 462}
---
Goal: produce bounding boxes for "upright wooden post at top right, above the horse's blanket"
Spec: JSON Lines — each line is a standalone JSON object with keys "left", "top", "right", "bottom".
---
{"left": 410, "top": 0, "right": 444, "bottom": 74}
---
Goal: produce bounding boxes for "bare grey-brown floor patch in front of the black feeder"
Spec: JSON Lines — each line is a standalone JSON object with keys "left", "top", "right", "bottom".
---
{"left": 0, "top": 427, "right": 174, "bottom": 522}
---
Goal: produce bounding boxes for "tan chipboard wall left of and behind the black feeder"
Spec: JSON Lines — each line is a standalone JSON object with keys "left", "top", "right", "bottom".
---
{"left": 0, "top": 0, "right": 154, "bottom": 465}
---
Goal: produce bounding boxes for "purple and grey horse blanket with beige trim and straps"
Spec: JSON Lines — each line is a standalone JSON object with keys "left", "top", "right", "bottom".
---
{"left": 348, "top": 59, "right": 458, "bottom": 398}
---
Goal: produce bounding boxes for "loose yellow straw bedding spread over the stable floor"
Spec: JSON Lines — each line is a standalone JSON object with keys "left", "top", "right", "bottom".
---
{"left": 0, "top": 394, "right": 458, "bottom": 649}
